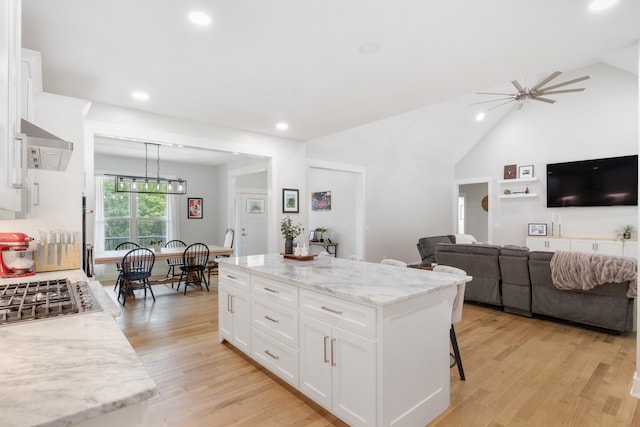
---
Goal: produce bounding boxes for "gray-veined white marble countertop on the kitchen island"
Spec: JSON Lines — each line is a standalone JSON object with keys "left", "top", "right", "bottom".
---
{"left": 218, "top": 254, "right": 472, "bottom": 306}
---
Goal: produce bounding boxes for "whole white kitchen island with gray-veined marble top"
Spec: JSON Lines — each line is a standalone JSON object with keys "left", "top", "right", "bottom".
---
{"left": 219, "top": 254, "right": 471, "bottom": 426}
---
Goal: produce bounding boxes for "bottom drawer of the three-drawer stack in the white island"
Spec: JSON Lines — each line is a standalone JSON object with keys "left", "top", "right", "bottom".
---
{"left": 251, "top": 328, "right": 299, "bottom": 388}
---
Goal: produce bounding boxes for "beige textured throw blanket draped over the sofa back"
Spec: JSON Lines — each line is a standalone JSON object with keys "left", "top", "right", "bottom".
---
{"left": 551, "top": 251, "right": 638, "bottom": 298}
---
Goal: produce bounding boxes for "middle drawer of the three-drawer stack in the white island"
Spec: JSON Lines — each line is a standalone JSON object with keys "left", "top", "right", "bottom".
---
{"left": 251, "top": 295, "right": 298, "bottom": 348}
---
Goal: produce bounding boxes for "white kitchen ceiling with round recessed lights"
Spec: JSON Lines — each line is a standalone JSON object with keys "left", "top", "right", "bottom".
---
{"left": 23, "top": 0, "right": 640, "bottom": 145}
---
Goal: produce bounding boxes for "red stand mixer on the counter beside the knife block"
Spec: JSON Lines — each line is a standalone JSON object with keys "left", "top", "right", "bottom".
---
{"left": 0, "top": 233, "right": 36, "bottom": 278}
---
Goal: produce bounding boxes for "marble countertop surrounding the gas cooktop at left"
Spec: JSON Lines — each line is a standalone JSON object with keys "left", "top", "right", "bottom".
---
{"left": 0, "top": 270, "right": 157, "bottom": 427}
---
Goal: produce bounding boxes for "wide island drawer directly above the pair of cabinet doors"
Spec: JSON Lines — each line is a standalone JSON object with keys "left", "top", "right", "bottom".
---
{"left": 300, "top": 289, "right": 376, "bottom": 336}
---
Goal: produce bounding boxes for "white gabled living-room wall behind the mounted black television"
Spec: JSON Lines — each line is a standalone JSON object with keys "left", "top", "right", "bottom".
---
{"left": 455, "top": 63, "right": 638, "bottom": 245}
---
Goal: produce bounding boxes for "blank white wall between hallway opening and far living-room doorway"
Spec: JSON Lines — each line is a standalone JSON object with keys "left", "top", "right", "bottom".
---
{"left": 306, "top": 113, "right": 454, "bottom": 262}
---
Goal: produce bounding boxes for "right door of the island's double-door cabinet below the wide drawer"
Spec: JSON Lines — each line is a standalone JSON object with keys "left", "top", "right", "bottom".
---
{"left": 330, "top": 327, "right": 376, "bottom": 426}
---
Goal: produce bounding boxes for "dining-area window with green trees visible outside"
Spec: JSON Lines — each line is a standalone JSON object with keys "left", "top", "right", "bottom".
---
{"left": 102, "top": 178, "right": 168, "bottom": 250}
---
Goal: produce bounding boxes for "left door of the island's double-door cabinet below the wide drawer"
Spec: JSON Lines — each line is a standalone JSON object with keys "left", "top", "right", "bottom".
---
{"left": 300, "top": 314, "right": 332, "bottom": 410}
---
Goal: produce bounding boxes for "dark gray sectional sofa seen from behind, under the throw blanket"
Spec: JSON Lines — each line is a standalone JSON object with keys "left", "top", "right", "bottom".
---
{"left": 435, "top": 244, "right": 635, "bottom": 332}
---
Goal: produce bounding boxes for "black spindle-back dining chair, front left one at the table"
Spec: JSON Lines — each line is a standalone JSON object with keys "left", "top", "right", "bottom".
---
{"left": 118, "top": 248, "right": 156, "bottom": 306}
